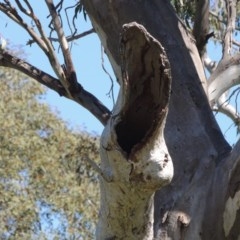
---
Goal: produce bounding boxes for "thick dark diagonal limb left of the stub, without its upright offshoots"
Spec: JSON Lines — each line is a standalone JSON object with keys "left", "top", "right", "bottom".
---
{"left": 0, "top": 51, "right": 111, "bottom": 125}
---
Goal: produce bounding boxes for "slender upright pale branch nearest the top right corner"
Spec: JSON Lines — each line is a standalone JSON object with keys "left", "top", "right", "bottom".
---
{"left": 223, "top": 0, "right": 237, "bottom": 59}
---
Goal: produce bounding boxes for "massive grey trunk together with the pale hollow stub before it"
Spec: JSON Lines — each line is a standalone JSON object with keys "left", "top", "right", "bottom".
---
{"left": 83, "top": 0, "right": 240, "bottom": 240}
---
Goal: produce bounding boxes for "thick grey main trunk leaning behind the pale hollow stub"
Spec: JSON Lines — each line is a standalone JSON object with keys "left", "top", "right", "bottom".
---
{"left": 83, "top": 0, "right": 240, "bottom": 239}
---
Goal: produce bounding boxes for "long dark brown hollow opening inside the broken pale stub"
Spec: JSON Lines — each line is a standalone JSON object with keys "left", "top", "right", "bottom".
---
{"left": 115, "top": 23, "right": 171, "bottom": 155}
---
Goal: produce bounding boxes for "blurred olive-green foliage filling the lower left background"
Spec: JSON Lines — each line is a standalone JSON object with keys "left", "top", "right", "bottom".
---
{"left": 0, "top": 68, "right": 99, "bottom": 239}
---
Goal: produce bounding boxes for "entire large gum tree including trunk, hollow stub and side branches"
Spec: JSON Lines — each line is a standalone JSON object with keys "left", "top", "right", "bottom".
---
{"left": 0, "top": 0, "right": 240, "bottom": 240}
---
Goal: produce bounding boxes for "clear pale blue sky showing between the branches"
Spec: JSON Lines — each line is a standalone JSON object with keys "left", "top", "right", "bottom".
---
{"left": 0, "top": 1, "right": 240, "bottom": 144}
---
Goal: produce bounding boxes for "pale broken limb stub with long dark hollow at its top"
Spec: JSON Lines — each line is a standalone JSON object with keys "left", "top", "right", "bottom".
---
{"left": 96, "top": 23, "right": 173, "bottom": 240}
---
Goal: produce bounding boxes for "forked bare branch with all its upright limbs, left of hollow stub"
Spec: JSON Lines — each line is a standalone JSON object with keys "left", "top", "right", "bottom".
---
{"left": 0, "top": 0, "right": 111, "bottom": 125}
